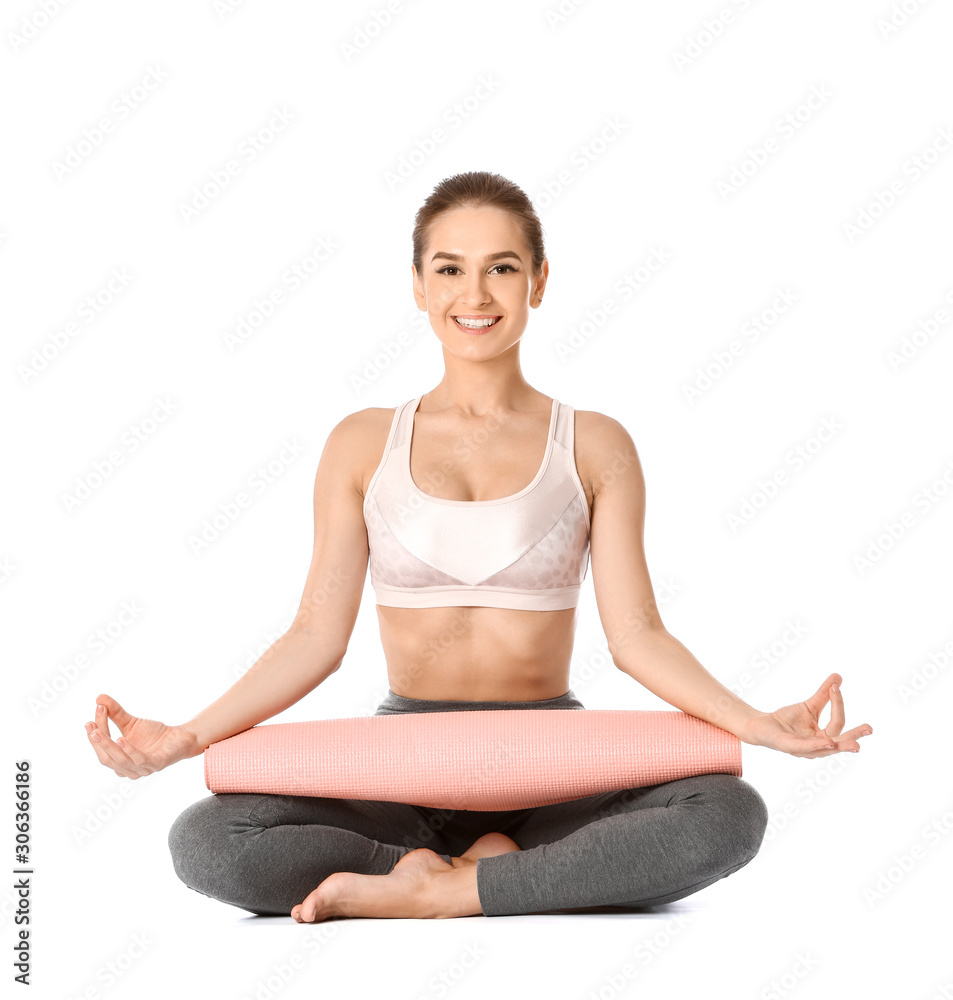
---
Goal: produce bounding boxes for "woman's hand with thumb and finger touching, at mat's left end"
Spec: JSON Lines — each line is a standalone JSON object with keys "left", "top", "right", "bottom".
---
{"left": 86, "top": 694, "right": 202, "bottom": 779}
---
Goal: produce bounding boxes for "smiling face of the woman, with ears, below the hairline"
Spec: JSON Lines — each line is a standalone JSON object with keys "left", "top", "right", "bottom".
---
{"left": 411, "top": 206, "right": 549, "bottom": 357}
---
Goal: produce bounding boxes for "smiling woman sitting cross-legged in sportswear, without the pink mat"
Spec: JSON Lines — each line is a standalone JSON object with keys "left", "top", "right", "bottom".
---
{"left": 86, "top": 172, "right": 871, "bottom": 922}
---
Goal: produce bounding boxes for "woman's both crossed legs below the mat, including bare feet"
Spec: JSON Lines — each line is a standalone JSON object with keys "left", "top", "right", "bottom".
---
{"left": 169, "top": 774, "right": 768, "bottom": 922}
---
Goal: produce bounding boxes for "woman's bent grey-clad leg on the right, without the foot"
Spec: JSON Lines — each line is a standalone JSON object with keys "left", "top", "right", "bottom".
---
{"left": 477, "top": 774, "right": 768, "bottom": 916}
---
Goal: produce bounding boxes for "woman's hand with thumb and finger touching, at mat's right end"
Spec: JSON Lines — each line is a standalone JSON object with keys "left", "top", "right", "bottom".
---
{"left": 738, "top": 674, "right": 873, "bottom": 757}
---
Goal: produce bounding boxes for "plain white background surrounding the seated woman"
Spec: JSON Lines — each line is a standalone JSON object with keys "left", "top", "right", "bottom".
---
{"left": 0, "top": 0, "right": 953, "bottom": 1000}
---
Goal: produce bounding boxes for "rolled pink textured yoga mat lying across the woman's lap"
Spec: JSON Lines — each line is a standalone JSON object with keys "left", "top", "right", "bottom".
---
{"left": 205, "top": 709, "right": 741, "bottom": 811}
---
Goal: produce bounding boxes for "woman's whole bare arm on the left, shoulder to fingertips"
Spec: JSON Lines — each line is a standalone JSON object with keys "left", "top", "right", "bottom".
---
{"left": 86, "top": 410, "right": 373, "bottom": 778}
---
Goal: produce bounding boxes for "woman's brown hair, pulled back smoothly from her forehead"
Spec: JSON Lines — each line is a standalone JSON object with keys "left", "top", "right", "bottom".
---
{"left": 413, "top": 170, "right": 546, "bottom": 274}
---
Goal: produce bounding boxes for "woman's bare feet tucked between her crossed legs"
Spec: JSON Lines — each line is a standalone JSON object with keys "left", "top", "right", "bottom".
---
{"left": 291, "top": 833, "right": 520, "bottom": 924}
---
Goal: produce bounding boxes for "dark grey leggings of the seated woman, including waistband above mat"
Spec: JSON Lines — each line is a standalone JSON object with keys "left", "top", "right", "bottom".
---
{"left": 169, "top": 690, "right": 768, "bottom": 916}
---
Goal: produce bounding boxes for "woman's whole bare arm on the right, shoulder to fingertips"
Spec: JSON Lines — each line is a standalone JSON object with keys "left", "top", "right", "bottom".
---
{"left": 576, "top": 411, "right": 873, "bottom": 757}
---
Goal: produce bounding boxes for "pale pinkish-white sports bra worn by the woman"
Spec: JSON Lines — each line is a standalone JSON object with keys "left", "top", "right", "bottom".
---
{"left": 364, "top": 396, "right": 589, "bottom": 611}
